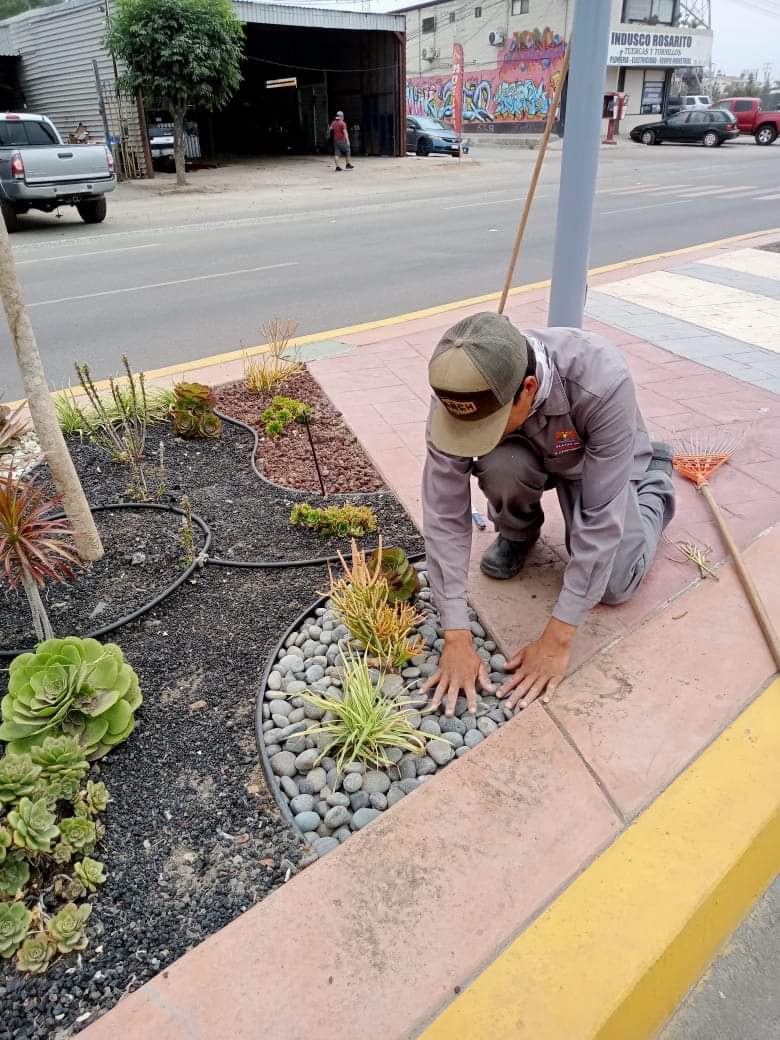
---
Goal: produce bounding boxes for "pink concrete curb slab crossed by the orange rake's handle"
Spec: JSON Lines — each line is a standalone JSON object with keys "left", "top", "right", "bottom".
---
{"left": 550, "top": 528, "right": 780, "bottom": 817}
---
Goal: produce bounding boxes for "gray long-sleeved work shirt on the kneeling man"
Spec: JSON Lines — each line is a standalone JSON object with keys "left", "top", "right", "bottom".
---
{"left": 422, "top": 329, "right": 652, "bottom": 629}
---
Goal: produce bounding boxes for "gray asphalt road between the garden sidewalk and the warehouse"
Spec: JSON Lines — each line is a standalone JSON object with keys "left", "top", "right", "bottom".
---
{"left": 0, "top": 141, "right": 780, "bottom": 399}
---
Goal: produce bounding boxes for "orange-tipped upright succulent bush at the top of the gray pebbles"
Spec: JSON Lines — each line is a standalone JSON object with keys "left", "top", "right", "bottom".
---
{"left": 330, "top": 540, "right": 423, "bottom": 669}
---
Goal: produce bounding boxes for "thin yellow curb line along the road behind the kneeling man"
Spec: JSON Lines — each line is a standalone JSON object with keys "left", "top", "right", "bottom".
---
{"left": 7, "top": 228, "right": 780, "bottom": 408}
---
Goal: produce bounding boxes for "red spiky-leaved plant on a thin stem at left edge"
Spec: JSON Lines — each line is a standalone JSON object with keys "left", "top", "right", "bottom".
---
{"left": 0, "top": 473, "right": 79, "bottom": 640}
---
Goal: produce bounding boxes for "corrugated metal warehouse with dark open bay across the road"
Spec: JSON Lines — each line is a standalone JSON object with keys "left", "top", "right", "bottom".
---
{"left": 0, "top": 0, "right": 406, "bottom": 177}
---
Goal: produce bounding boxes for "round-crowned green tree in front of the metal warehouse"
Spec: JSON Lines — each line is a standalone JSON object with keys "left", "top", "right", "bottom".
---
{"left": 106, "top": 0, "right": 243, "bottom": 184}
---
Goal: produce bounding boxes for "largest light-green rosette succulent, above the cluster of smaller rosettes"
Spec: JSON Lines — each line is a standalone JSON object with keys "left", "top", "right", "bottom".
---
{"left": 0, "top": 635, "right": 142, "bottom": 757}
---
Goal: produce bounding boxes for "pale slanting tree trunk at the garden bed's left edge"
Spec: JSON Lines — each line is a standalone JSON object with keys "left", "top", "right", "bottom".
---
{"left": 0, "top": 216, "right": 103, "bottom": 561}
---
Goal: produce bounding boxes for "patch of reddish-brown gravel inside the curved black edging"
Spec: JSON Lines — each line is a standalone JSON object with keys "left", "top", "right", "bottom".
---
{"left": 216, "top": 371, "right": 384, "bottom": 494}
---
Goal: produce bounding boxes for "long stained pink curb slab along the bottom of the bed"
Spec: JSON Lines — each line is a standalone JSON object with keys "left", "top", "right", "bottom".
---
{"left": 82, "top": 706, "right": 619, "bottom": 1040}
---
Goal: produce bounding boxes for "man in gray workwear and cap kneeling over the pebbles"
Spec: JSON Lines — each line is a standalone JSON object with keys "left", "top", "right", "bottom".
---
{"left": 422, "top": 313, "right": 675, "bottom": 714}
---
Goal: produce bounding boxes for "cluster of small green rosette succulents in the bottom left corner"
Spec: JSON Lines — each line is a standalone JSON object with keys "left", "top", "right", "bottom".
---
{"left": 0, "top": 737, "right": 109, "bottom": 974}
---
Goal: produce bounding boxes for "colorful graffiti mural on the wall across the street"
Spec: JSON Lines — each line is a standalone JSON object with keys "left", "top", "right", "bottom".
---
{"left": 407, "top": 29, "right": 565, "bottom": 126}
